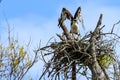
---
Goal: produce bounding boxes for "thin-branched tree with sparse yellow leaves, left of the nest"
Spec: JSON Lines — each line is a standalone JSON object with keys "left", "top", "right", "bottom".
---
{"left": 0, "top": 29, "right": 38, "bottom": 80}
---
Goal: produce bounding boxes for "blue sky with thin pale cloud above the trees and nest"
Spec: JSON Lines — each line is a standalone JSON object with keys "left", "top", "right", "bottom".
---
{"left": 0, "top": 0, "right": 120, "bottom": 77}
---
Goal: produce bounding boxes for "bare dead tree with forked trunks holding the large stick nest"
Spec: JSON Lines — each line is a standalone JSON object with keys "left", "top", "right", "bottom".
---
{"left": 38, "top": 6, "right": 120, "bottom": 80}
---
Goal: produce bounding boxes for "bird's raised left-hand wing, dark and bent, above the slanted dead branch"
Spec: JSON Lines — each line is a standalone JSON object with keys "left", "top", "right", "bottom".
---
{"left": 58, "top": 8, "right": 73, "bottom": 26}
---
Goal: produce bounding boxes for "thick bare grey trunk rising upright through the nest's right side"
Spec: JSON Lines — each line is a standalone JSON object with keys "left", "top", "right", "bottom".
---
{"left": 89, "top": 14, "right": 102, "bottom": 80}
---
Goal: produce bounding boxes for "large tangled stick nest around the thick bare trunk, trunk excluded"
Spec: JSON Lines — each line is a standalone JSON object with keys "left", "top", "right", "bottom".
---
{"left": 41, "top": 33, "right": 115, "bottom": 78}
